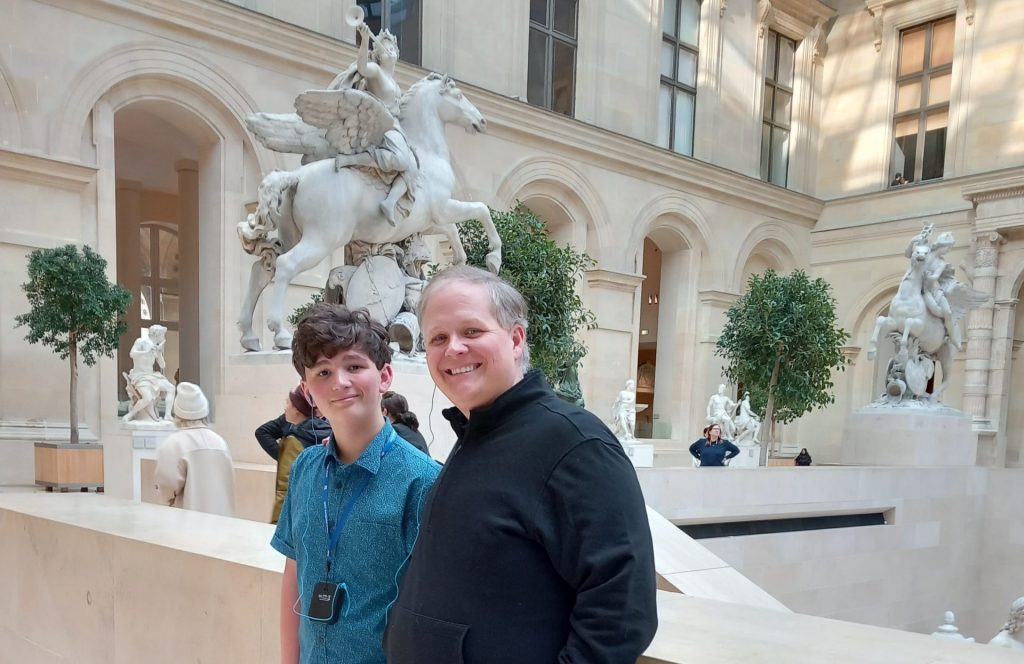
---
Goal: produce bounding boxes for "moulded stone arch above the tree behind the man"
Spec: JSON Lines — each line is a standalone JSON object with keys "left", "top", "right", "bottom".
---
{"left": 495, "top": 157, "right": 610, "bottom": 264}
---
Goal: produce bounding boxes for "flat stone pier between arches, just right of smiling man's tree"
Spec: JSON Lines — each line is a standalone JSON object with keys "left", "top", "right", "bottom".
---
{"left": 580, "top": 269, "right": 644, "bottom": 430}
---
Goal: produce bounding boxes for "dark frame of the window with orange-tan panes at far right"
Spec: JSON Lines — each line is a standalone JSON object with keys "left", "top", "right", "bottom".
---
{"left": 887, "top": 13, "right": 956, "bottom": 189}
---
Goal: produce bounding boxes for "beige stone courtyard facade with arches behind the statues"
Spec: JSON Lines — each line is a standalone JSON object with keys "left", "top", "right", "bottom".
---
{"left": 0, "top": 0, "right": 1024, "bottom": 477}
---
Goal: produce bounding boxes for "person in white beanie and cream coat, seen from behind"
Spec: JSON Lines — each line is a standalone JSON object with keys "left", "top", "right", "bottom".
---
{"left": 156, "top": 382, "right": 234, "bottom": 516}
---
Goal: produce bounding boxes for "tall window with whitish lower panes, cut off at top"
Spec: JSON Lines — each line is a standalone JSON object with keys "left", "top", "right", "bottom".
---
{"left": 657, "top": 0, "right": 700, "bottom": 156}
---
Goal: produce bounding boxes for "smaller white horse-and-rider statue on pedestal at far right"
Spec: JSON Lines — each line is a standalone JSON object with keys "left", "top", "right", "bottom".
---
{"left": 867, "top": 223, "right": 988, "bottom": 406}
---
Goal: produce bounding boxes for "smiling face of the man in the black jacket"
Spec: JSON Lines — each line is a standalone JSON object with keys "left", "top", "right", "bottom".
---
{"left": 423, "top": 282, "right": 526, "bottom": 416}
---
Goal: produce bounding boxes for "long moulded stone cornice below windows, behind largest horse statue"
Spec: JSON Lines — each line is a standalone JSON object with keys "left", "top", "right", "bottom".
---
{"left": 40, "top": 0, "right": 821, "bottom": 227}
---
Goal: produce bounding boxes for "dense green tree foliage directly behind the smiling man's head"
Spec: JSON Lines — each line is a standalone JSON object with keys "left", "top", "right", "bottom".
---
{"left": 459, "top": 206, "right": 595, "bottom": 387}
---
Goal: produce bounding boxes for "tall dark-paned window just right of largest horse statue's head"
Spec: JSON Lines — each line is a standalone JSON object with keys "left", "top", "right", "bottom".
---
{"left": 526, "top": 0, "right": 577, "bottom": 116}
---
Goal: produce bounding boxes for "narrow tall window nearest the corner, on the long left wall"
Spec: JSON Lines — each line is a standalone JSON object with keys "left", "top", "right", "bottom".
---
{"left": 761, "top": 30, "right": 797, "bottom": 186}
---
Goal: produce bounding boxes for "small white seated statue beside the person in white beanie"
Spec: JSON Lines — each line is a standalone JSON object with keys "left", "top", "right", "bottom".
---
{"left": 121, "top": 325, "right": 175, "bottom": 422}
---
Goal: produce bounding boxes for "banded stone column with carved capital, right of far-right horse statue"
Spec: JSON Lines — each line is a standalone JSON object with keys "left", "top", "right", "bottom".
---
{"left": 964, "top": 232, "right": 1006, "bottom": 431}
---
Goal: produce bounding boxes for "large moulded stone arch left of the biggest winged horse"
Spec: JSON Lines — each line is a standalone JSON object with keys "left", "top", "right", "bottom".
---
{"left": 49, "top": 43, "right": 274, "bottom": 172}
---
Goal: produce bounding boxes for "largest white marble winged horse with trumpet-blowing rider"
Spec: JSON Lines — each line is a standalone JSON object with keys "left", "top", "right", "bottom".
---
{"left": 238, "top": 7, "right": 502, "bottom": 350}
